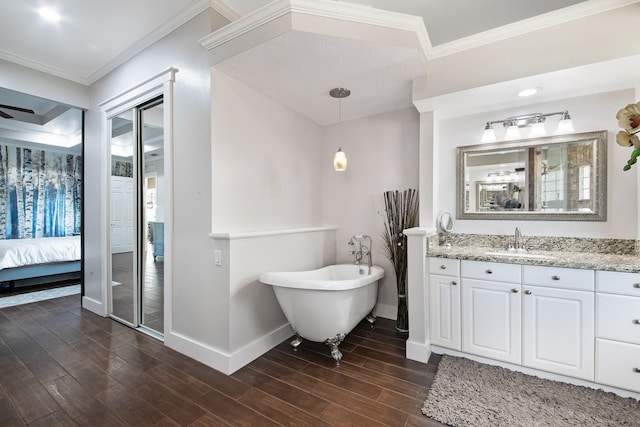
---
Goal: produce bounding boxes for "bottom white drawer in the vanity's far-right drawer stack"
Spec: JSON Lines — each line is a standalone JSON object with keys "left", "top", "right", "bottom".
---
{"left": 596, "top": 339, "right": 640, "bottom": 392}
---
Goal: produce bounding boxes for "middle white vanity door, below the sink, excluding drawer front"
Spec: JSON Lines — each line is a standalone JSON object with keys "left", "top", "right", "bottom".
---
{"left": 461, "top": 278, "right": 522, "bottom": 364}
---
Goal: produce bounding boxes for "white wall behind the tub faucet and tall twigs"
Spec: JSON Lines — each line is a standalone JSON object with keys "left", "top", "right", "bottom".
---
{"left": 318, "top": 109, "right": 419, "bottom": 318}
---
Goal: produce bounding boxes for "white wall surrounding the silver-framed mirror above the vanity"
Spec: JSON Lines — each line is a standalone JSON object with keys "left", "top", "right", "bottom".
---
{"left": 436, "top": 89, "right": 637, "bottom": 239}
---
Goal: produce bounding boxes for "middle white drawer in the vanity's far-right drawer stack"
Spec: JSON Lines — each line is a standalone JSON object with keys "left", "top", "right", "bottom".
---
{"left": 596, "top": 293, "right": 640, "bottom": 344}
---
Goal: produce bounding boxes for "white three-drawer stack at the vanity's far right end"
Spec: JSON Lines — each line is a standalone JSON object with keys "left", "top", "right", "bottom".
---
{"left": 595, "top": 271, "right": 640, "bottom": 392}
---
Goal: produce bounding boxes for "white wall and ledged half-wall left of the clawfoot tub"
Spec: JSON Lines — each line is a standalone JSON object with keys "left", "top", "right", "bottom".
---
{"left": 210, "top": 69, "right": 336, "bottom": 373}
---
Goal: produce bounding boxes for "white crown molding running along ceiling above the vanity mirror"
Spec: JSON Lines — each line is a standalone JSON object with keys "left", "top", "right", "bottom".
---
{"left": 427, "top": 0, "right": 640, "bottom": 60}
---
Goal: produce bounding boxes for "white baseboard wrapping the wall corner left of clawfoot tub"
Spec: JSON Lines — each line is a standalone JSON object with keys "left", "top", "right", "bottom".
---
{"left": 164, "top": 324, "right": 293, "bottom": 375}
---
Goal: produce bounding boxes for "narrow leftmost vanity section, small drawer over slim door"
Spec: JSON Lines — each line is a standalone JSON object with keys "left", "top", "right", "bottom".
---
{"left": 428, "top": 258, "right": 462, "bottom": 351}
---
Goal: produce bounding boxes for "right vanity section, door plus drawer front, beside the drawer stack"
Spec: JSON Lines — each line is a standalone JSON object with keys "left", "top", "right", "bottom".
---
{"left": 522, "top": 265, "right": 595, "bottom": 381}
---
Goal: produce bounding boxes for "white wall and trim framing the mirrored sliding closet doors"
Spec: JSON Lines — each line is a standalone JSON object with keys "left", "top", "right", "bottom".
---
{"left": 85, "top": 9, "right": 228, "bottom": 348}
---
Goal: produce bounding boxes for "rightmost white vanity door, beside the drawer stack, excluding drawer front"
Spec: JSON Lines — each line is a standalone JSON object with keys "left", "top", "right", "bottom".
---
{"left": 522, "top": 286, "right": 595, "bottom": 381}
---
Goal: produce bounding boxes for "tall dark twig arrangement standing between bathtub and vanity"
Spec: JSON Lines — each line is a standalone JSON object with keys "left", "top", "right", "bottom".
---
{"left": 383, "top": 188, "right": 418, "bottom": 332}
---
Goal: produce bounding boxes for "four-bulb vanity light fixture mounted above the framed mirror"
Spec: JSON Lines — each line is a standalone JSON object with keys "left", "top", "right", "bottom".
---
{"left": 481, "top": 110, "right": 575, "bottom": 142}
